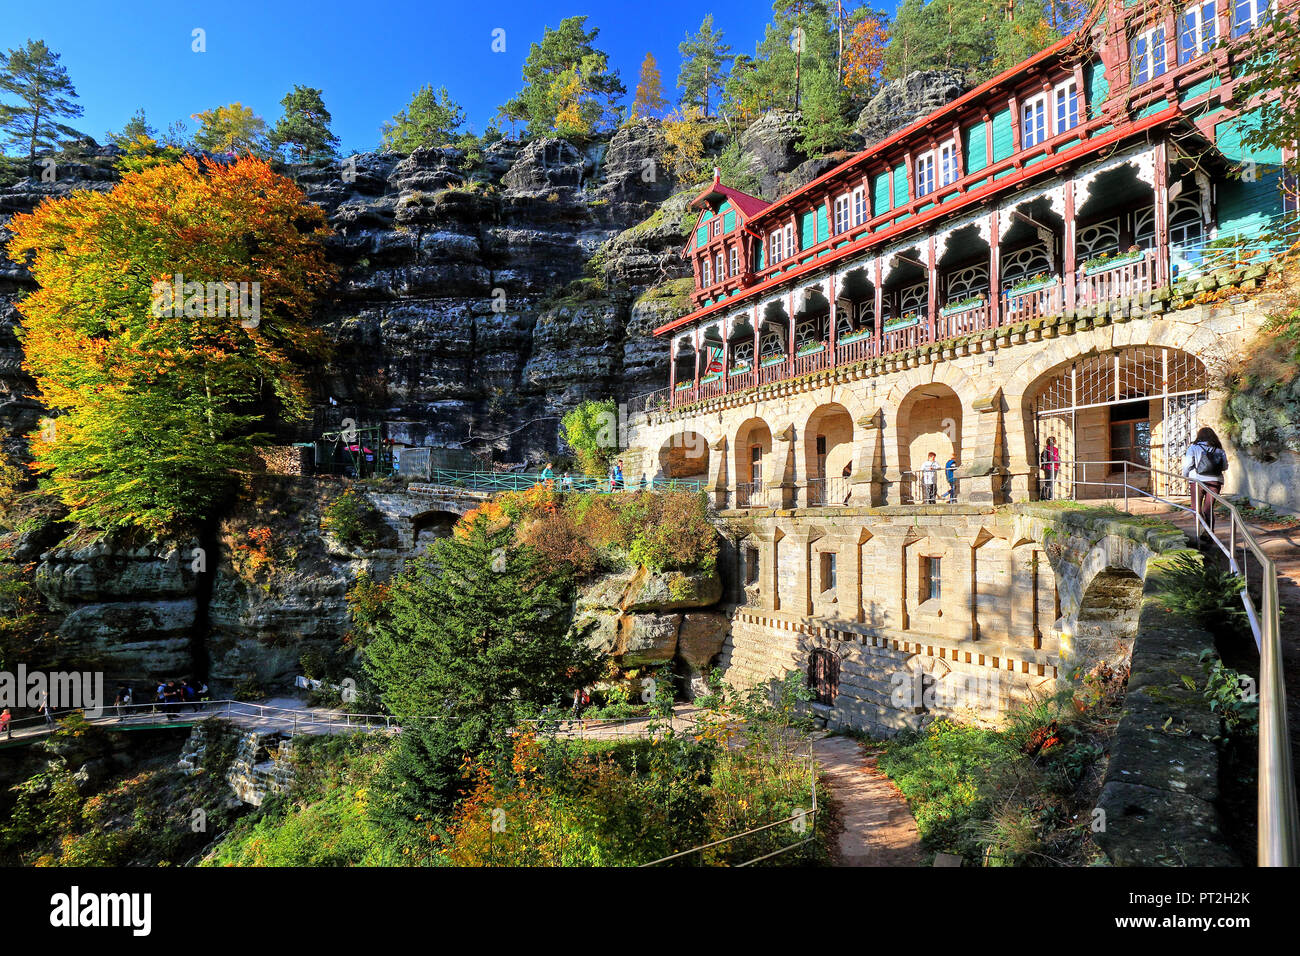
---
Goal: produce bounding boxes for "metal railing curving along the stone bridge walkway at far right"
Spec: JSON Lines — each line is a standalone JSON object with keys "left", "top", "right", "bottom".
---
{"left": 1044, "top": 462, "right": 1300, "bottom": 866}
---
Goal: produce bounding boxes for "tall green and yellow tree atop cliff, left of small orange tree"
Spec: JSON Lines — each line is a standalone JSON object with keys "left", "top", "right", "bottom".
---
{"left": 499, "top": 17, "right": 628, "bottom": 135}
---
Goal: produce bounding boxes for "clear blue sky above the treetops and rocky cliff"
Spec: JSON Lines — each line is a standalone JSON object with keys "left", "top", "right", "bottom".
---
{"left": 0, "top": 0, "right": 893, "bottom": 150}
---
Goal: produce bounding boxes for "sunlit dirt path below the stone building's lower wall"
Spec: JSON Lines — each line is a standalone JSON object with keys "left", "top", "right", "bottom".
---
{"left": 813, "top": 736, "right": 922, "bottom": 866}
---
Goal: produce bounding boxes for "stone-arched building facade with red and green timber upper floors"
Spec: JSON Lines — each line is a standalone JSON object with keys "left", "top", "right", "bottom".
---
{"left": 625, "top": 0, "right": 1291, "bottom": 726}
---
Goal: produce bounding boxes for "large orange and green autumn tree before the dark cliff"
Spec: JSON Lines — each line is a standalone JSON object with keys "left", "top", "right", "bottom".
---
{"left": 8, "top": 156, "right": 332, "bottom": 535}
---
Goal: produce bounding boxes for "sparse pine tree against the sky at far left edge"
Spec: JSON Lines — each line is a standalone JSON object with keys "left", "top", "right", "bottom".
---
{"left": 0, "top": 40, "right": 85, "bottom": 164}
